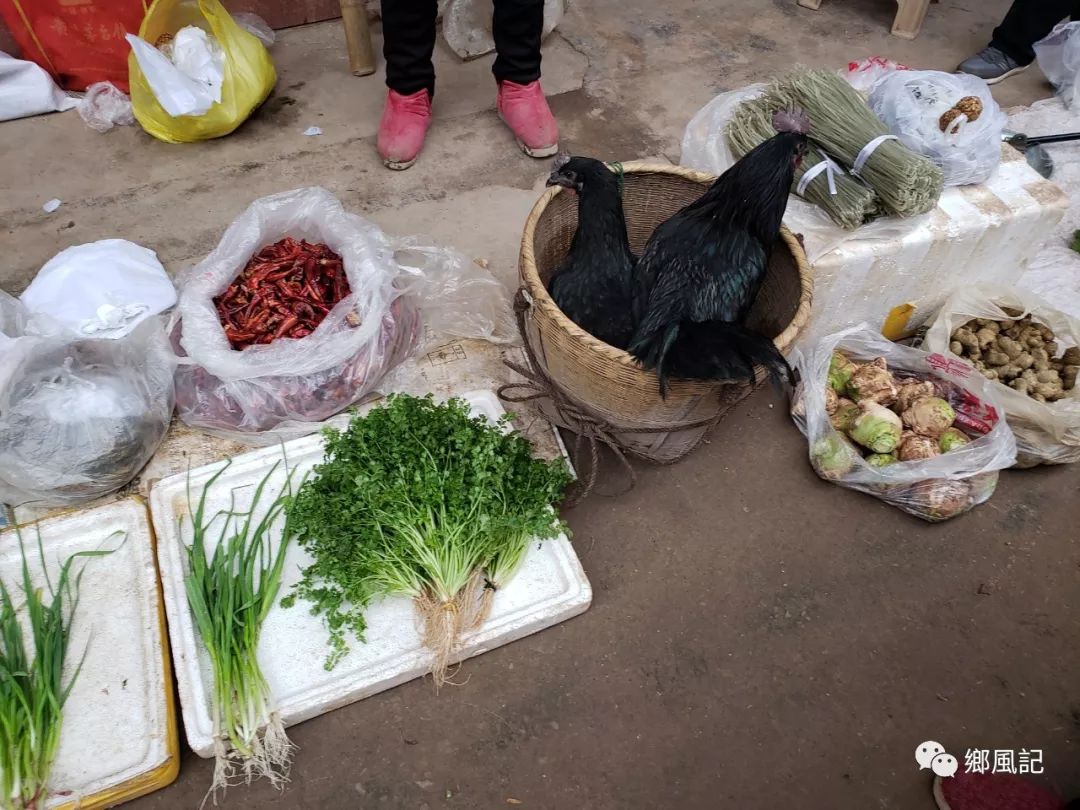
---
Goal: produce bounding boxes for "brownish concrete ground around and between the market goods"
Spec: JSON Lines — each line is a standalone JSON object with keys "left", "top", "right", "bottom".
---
{"left": 0, "top": 0, "right": 1080, "bottom": 810}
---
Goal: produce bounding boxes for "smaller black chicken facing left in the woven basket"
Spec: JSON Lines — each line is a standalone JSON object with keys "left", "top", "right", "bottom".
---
{"left": 548, "top": 158, "right": 636, "bottom": 349}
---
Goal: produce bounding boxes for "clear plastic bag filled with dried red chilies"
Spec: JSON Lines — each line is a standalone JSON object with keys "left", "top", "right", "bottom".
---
{"left": 170, "top": 188, "right": 507, "bottom": 444}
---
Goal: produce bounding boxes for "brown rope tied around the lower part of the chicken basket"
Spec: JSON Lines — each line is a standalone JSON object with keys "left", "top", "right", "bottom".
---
{"left": 497, "top": 287, "right": 724, "bottom": 507}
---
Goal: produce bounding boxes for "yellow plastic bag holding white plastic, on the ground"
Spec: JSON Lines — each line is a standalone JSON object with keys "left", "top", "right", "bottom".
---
{"left": 127, "top": 0, "right": 278, "bottom": 144}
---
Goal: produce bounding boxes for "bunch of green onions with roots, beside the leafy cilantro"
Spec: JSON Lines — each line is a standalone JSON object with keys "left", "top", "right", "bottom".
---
{"left": 184, "top": 461, "right": 294, "bottom": 796}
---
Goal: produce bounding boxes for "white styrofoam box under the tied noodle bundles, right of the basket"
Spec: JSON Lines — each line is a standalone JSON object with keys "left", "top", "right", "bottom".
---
{"left": 801, "top": 146, "right": 1068, "bottom": 341}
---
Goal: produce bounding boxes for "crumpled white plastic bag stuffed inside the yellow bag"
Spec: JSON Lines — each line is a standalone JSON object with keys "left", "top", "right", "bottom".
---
{"left": 125, "top": 26, "right": 225, "bottom": 118}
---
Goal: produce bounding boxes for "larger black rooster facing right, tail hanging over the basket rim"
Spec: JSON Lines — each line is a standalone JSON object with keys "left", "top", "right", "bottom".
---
{"left": 629, "top": 110, "right": 809, "bottom": 396}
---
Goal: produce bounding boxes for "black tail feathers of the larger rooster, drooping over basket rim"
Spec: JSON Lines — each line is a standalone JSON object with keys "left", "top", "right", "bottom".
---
{"left": 665, "top": 321, "right": 792, "bottom": 391}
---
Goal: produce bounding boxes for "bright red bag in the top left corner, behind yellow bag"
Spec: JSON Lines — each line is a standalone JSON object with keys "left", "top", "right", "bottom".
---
{"left": 0, "top": 0, "right": 148, "bottom": 93}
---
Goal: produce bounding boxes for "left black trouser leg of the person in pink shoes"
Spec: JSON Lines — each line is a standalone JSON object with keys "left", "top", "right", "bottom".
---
{"left": 382, "top": 0, "right": 438, "bottom": 95}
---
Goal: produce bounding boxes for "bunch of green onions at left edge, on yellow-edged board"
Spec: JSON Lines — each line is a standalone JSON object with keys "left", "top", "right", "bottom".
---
{"left": 0, "top": 527, "right": 112, "bottom": 810}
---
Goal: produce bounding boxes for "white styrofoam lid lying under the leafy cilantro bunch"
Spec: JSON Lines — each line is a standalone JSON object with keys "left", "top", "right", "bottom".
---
{"left": 150, "top": 391, "right": 592, "bottom": 757}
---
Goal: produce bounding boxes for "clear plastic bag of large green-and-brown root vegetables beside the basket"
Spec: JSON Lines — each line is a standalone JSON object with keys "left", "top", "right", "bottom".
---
{"left": 791, "top": 324, "right": 1016, "bottom": 522}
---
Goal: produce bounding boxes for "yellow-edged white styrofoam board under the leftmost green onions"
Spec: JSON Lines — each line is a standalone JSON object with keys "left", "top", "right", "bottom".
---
{"left": 0, "top": 498, "right": 179, "bottom": 808}
